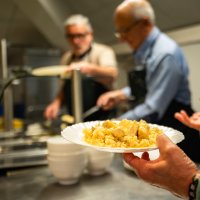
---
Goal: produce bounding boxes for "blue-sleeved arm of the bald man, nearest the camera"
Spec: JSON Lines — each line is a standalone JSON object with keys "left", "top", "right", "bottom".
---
{"left": 120, "top": 55, "right": 182, "bottom": 120}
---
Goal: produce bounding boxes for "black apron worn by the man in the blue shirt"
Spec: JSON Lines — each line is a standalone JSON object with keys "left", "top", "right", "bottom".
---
{"left": 128, "top": 65, "right": 200, "bottom": 162}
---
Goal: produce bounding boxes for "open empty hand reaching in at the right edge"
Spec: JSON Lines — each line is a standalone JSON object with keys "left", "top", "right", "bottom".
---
{"left": 174, "top": 110, "right": 200, "bottom": 131}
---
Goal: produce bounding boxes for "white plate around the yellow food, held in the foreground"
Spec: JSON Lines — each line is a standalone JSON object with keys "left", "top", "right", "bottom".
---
{"left": 61, "top": 121, "right": 184, "bottom": 153}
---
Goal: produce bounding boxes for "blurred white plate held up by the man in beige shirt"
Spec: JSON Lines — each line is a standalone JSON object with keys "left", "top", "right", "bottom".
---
{"left": 32, "top": 65, "right": 70, "bottom": 76}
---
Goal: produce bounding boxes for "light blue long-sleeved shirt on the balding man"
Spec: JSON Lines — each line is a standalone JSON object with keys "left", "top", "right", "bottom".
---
{"left": 120, "top": 27, "right": 191, "bottom": 120}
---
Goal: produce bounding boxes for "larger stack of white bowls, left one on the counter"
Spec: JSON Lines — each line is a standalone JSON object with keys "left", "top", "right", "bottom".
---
{"left": 47, "top": 136, "right": 88, "bottom": 185}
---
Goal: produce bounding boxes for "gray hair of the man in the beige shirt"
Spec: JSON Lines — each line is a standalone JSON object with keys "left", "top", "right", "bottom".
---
{"left": 64, "top": 14, "right": 93, "bottom": 31}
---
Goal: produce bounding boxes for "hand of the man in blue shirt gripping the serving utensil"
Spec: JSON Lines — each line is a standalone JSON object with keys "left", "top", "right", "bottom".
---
{"left": 97, "top": 90, "right": 127, "bottom": 110}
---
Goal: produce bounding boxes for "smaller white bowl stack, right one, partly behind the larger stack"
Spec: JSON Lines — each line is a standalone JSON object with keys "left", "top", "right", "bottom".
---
{"left": 87, "top": 148, "right": 114, "bottom": 176}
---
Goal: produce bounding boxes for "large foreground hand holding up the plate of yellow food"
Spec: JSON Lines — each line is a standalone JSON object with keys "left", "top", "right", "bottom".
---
{"left": 124, "top": 134, "right": 197, "bottom": 198}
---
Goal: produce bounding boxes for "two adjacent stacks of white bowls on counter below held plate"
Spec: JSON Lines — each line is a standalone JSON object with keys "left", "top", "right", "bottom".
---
{"left": 47, "top": 136, "right": 114, "bottom": 185}
